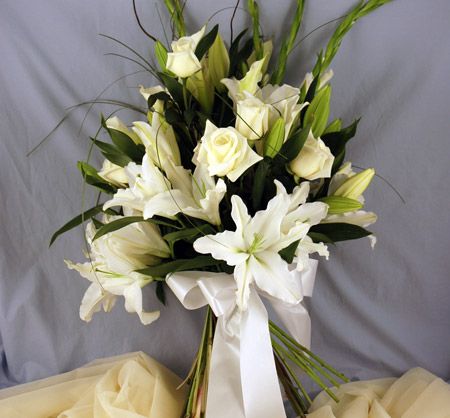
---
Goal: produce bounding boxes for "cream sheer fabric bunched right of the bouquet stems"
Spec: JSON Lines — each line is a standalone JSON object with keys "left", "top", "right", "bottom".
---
{"left": 308, "top": 368, "right": 450, "bottom": 418}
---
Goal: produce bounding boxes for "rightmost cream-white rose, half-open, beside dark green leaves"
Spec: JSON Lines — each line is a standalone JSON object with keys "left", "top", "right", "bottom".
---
{"left": 289, "top": 132, "right": 334, "bottom": 180}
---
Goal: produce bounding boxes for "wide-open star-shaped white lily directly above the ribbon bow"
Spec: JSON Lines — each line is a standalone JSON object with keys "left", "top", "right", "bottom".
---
{"left": 194, "top": 180, "right": 326, "bottom": 310}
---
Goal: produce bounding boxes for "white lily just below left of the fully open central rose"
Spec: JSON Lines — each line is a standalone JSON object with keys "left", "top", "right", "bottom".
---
{"left": 144, "top": 163, "right": 227, "bottom": 225}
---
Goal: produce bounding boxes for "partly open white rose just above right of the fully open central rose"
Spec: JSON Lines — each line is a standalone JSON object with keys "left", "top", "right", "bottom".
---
{"left": 236, "top": 97, "right": 270, "bottom": 140}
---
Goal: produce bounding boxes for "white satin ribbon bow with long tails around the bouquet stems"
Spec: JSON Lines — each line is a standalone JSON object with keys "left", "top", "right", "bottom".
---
{"left": 167, "top": 260, "right": 317, "bottom": 418}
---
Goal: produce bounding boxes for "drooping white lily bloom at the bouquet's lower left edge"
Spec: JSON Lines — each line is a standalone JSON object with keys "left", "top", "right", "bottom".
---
{"left": 66, "top": 217, "right": 170, "bottom": 324}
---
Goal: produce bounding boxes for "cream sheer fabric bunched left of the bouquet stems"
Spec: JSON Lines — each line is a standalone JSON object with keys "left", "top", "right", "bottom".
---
{"left": 0, "top": 352, "right": 186, "bottom": 418}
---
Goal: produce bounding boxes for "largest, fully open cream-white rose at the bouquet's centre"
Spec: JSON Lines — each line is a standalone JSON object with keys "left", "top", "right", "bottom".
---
{"left": 194, "top": 121, "right": 262, "bottom": 181}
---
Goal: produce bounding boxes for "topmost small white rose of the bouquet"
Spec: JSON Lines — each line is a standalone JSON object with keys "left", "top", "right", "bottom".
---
{"left": 166, "top": 26, "right": 206, "bottom": 78}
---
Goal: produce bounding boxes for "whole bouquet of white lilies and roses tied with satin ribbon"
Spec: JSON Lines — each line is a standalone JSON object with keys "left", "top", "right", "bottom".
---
{"left": 47, "top": 0, "right": 388, "bottom": 418}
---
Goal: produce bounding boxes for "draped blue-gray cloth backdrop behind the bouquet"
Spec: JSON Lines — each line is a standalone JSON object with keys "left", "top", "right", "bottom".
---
{"left": 0, "top": 0, "right": 450, "bottom": 398}
